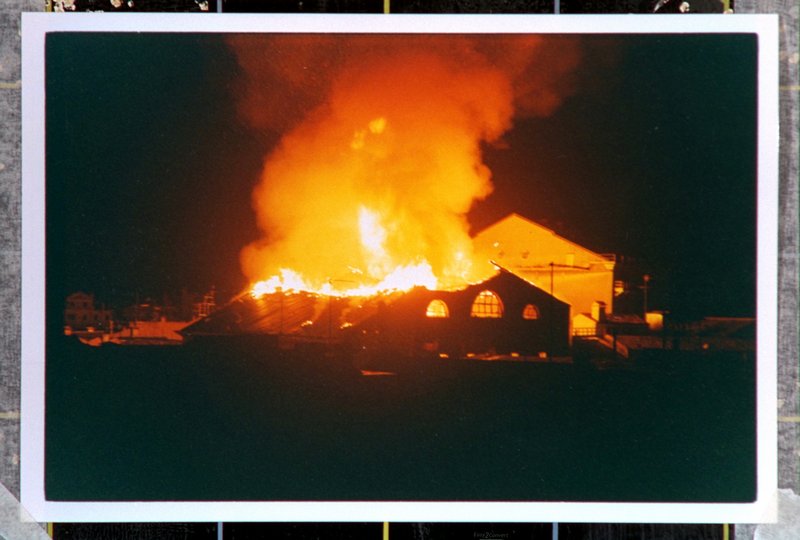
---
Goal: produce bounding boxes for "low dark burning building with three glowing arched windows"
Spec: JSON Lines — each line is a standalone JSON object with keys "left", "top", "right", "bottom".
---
{"left": 181, "top": 264, "right": 571, "bottom": 358}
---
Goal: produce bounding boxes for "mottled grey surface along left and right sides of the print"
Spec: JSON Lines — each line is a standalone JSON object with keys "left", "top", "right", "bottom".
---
{"left": 0, "top": 0, "right": 800, "bottom": 538}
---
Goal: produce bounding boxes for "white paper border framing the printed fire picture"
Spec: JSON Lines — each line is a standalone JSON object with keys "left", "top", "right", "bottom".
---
{"left": 20, "top": 13, "right": 779, "bottom": 523}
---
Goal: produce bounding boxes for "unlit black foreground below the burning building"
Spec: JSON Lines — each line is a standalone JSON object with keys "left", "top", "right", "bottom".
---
{"left": 45, "top": 340, "right": 756, "bottom": 502}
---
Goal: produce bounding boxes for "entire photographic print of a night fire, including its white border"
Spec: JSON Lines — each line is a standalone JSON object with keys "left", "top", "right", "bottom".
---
{"left": 23, "top": 16, "right": 777, "bottom": 522}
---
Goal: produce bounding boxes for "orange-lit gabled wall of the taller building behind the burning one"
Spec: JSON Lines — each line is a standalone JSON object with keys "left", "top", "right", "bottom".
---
{"left": 473, "top": 214, "right": 615, "bottom": 314}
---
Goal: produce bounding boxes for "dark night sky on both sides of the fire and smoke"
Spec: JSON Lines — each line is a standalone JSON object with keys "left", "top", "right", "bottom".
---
{"left": 46, "top": 33, "right": 756, "bottom": 315}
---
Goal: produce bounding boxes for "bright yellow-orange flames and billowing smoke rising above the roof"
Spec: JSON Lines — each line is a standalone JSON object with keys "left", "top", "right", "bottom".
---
{"left": 230, "top": 36, "right": 577, "bottom": 296}
